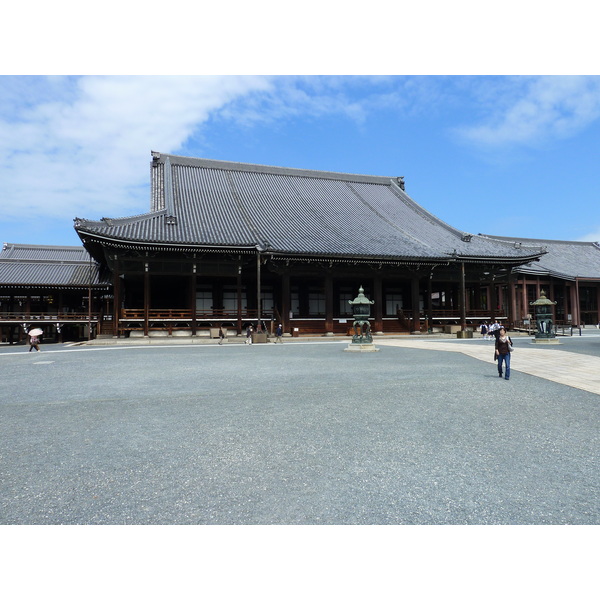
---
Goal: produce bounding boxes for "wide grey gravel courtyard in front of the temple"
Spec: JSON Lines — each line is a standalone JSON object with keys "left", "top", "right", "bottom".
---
{"left": 0, "top": 342, "right": 600, "bottom": 525}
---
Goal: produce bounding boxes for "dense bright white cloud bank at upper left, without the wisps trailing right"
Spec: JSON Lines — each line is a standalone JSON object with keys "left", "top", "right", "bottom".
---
{"left": 0, "top": 76, "right": 271, "bottom": 219}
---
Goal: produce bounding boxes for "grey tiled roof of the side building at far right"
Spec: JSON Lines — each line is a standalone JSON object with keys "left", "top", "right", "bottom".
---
{"left": 486, "top": 236, "right": 600, "bottom": 280}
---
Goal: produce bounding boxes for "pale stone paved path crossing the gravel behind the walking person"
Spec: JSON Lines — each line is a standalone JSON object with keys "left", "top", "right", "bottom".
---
{"left": 375, "top": 338, "right": 600, "bottom": 395}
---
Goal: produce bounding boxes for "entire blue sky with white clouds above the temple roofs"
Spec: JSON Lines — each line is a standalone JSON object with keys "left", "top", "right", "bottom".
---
{"left": 0, "top": 75, "right": 600, "bottom": 244}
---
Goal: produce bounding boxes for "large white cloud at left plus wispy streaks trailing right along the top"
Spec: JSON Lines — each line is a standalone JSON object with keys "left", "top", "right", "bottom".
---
{"left": 0, "top": 76, "right": 432, "bottom": 229}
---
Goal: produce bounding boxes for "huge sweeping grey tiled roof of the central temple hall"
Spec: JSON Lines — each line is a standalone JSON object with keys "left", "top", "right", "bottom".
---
{"left": 75, "top": 153, "right": 540, "bottom": 261}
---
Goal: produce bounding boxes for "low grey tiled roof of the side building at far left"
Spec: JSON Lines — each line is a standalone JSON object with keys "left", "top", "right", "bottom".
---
{"left": 0, "top": 244, "right": 109, "bottom": 287}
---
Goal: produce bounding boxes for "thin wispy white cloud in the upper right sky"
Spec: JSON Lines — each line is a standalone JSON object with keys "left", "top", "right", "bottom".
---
{"left": 460, "top": 76, "right": 600, "bottom": 147}
